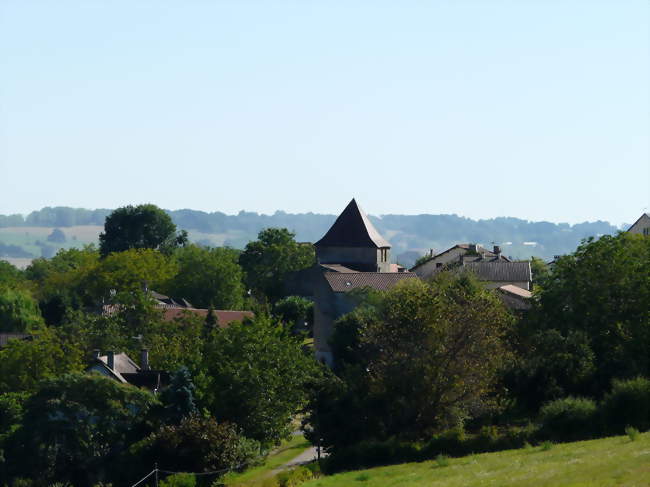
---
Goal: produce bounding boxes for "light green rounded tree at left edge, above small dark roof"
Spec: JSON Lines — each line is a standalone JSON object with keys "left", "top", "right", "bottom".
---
{"left": 0, "top": 285, "right": 43, "bottom": 332}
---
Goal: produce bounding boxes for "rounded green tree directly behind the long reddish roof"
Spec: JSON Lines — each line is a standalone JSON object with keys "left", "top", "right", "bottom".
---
{"left": 166, "top": 245, "right": 244, "bottom": 309}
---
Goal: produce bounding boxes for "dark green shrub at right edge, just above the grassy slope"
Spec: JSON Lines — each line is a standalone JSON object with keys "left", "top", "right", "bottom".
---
{"left": 601, "top": 377, "right": 650, "bottom": 434}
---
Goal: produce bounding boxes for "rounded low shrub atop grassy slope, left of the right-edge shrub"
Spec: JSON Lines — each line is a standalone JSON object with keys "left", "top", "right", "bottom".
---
{"left": 539, "top": 397, "right": 600, "bottom": 441}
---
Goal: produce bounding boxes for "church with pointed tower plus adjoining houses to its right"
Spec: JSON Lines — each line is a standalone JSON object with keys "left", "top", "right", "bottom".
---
{"left": 296, "top": 199, "right": 532, "bottom": 365}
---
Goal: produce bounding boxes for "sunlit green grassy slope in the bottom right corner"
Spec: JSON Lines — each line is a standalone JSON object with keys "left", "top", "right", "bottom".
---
{"left": 302, "top": 432, "right": 650, "bottom": 487}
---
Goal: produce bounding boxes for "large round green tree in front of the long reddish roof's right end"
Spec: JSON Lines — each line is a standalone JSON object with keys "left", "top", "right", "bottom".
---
{"left": 203, "top": 316, "right": 318, "bottom": 446}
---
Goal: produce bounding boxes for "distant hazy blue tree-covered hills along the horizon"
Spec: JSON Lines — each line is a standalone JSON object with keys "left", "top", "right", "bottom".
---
{"left": 0, "top": 207, "right": 618, "bottom": 266}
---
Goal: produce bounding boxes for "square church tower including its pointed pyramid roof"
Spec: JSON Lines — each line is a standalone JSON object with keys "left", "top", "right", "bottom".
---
{"left": 314, "top": 199, "right": 390, "bottom": 272}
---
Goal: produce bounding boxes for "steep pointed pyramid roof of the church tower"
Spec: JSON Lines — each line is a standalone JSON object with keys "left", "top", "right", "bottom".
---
{"left": 315, "top": 198, "right": 390, "bottom": 248}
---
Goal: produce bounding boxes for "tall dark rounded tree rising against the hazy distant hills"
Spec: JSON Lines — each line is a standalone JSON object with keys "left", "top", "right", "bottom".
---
{"left": 99, "top": 204, "right": 187, "bottom": 257}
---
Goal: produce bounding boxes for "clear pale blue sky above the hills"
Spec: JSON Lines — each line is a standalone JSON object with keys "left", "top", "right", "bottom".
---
{"left": 0, "top": 0, "right": 650, "bottom": 223}
